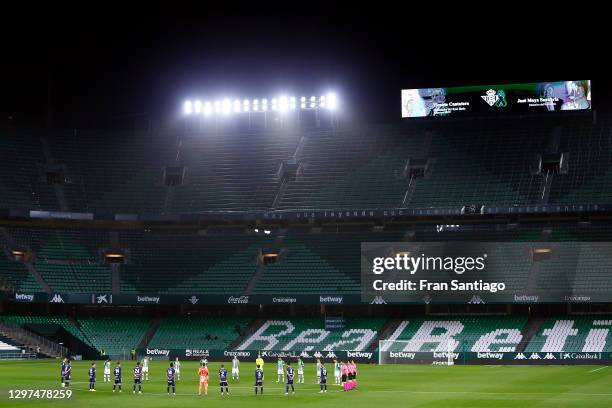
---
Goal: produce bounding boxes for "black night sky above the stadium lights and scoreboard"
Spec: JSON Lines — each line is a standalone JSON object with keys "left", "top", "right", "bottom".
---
{"left": 0, "top": 8, "right": 612, "bottom": 128}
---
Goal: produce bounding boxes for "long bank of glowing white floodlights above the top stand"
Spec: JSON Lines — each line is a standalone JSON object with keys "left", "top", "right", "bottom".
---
{"left": 183, "top": 92, "right": 338, "bottom": 116}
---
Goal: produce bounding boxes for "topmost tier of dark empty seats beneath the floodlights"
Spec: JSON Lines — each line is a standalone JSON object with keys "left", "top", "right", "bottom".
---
{"left": 0, "top": 116, "right": 612, "bottom": 215}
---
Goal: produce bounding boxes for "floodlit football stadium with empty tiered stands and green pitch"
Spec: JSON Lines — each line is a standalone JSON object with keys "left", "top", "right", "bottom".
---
{"left": 0, "top": 9, "right": 612, "bottom": 408}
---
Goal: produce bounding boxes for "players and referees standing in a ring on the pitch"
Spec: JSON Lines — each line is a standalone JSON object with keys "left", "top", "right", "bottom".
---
{"left": 61, "top": 355, "right": 357, "bottom": 396}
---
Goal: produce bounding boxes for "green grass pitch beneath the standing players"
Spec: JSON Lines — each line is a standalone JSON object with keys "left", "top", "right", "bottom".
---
{"left": 0, "top": 360, "right": 612, "bottom": 408}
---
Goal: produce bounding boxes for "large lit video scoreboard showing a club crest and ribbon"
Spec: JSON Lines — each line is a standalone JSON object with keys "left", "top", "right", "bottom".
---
{"left": 402, "top": 80, "right": 591, "bottom": 118}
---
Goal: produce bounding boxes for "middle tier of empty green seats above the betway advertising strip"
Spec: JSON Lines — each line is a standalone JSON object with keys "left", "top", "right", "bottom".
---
{"left": 0, "top": 222, "right": 612, "bottom": 296}
